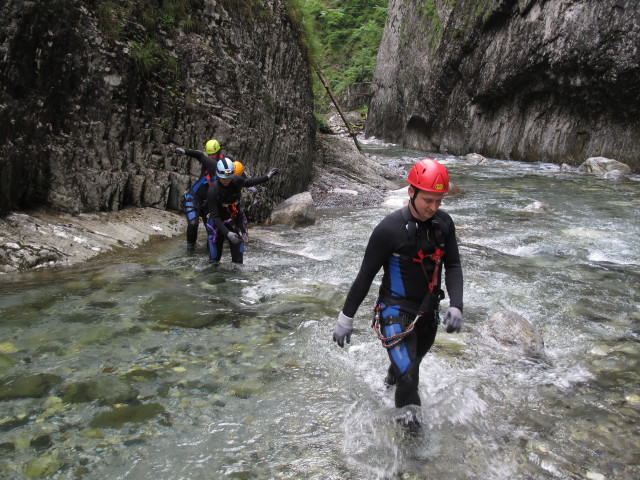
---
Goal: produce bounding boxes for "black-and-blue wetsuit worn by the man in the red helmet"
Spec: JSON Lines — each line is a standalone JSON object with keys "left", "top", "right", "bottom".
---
{"left": 342, "top": 207, "right": 462, "bottom": 407}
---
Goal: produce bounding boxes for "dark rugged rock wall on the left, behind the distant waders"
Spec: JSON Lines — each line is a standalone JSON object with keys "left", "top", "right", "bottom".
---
{"left": 0, "top": 0, "right": 315, "bottom": 221}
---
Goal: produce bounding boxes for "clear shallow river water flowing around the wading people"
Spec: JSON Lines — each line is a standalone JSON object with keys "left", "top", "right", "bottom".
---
{"left": 0, "top": 148, "right": 640, "bottom": 480}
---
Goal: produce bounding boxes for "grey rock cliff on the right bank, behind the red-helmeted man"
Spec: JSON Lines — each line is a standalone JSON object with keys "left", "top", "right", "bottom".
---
{"left": 366, "top": 0, "right": 640, "bottom": 171}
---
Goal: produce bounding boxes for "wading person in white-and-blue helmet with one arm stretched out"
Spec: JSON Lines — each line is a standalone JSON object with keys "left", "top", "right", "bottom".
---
{"left": 206, "top": 157, "right": 278, "bottom": 263}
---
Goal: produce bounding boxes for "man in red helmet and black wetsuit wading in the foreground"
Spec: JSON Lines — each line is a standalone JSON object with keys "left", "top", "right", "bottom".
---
{"left": 333, "top": 159, "right": 462, "bottom": 427}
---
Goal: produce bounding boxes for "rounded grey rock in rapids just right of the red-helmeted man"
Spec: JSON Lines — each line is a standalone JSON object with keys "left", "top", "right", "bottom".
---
{"left": 478, "top": 310, "right": 545, "bottom": 358}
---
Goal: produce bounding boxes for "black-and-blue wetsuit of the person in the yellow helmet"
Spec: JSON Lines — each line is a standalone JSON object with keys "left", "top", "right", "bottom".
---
{"left": 182, "top": 149, "right": 222, "bottom": 248}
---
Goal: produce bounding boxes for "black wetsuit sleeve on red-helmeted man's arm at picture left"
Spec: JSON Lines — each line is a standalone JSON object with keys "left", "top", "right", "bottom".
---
{"left": 342, "top": 219, "right": 394, "bottom": 318}
